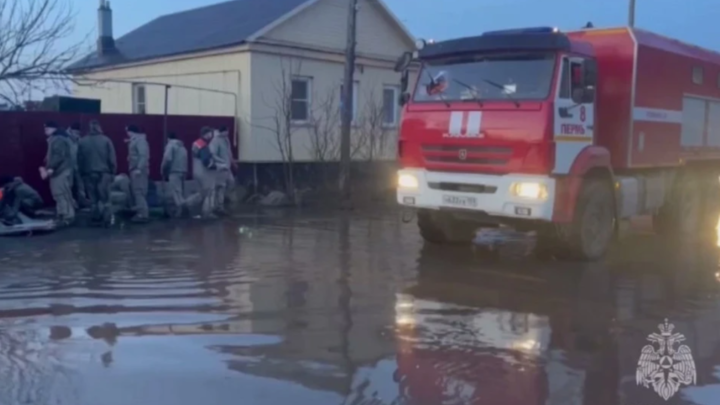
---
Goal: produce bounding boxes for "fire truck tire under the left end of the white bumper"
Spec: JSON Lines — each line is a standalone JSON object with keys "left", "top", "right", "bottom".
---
{"left": 417, "top": 210, "right": 477, "bottom": 244}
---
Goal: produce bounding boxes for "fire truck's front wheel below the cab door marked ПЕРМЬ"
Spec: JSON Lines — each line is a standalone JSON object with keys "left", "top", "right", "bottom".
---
{"left": 560, "top": 179, "right": 615, "bottom": 261}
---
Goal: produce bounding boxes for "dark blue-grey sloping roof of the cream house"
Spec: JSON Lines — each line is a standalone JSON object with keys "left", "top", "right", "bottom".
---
{"left": 69, "top": 0, "right": 311, "bottom": 71}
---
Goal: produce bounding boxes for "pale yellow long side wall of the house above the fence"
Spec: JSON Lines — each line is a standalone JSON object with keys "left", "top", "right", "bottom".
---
{"left": 73, "top": 52, "right": 251, "bottom": 137}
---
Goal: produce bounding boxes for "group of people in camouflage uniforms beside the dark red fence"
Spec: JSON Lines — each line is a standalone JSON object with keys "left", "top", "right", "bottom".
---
{"left": 3, "top": 121, "right": 235, "bottom": 225}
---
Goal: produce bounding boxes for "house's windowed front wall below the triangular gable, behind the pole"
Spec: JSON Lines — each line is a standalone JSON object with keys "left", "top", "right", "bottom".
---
{"left": 248, "top": 53, "right": 400, "bottom": 162}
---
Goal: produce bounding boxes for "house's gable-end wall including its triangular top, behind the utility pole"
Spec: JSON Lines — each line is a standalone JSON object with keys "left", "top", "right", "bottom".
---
{"left": 246, "top": 0, "right": 413, "bottom": 161}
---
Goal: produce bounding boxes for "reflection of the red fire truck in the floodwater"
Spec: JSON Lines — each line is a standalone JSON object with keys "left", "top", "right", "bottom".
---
{"left": 396, "top": 240, "right": 720, "bottom": 405}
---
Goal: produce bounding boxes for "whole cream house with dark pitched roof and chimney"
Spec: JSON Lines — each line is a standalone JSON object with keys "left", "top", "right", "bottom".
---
{"left": 71, "top": 0, "right": 414, "bottom": 163}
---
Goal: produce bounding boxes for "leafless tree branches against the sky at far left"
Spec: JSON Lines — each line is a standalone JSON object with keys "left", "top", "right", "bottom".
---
{"left": 0, "top": 0, "right": 85, "bottom": 105}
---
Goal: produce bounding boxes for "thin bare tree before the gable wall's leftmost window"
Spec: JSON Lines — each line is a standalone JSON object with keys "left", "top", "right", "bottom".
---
{"left": 253, "top": 58, "right": 302, "bottom": 198}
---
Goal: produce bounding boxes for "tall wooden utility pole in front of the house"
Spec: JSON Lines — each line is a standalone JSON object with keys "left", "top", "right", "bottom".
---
{"left": 340, "top": 0, "right": 358, "bottom": 203}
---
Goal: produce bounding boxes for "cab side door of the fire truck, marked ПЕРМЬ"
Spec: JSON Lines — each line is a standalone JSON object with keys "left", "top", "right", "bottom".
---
{"left": 553, "top": 56, "right": 595, "bottom": 174}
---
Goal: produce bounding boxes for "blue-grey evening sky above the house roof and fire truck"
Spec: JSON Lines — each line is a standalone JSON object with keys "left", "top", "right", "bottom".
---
{"left": 64, "top": 0, "right": 720, "bottom": 50}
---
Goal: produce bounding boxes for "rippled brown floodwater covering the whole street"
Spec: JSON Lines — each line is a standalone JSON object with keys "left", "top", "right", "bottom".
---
{"left": 0, "top": 211, "right": 720, "bottom": 405}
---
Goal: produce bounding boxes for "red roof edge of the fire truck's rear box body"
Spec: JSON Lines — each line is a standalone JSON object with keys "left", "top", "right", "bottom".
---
{"left": 567, "top": 27, "right": 720, "bottom": 65}
